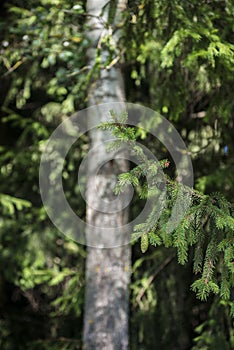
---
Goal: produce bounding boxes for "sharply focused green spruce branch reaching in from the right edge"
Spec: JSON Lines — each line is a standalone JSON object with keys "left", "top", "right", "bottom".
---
{"left": 100, "top": 111, "right": 234, "bottom": 315}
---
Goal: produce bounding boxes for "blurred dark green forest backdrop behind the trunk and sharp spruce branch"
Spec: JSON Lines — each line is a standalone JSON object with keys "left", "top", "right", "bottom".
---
{"left": 0, "top": 0, "right": 234, "bottom": 350}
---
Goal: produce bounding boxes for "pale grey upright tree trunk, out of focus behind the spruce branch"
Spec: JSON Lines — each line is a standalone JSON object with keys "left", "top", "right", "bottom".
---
{"left": 84, "top": 0, "right": 130, "bottom": 350}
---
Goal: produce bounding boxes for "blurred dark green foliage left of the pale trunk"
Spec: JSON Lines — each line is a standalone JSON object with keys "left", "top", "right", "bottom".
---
{"left": 0, "top": 1, "right": 87, "bottom": 350}
